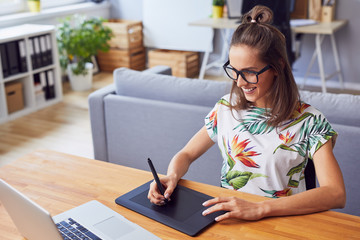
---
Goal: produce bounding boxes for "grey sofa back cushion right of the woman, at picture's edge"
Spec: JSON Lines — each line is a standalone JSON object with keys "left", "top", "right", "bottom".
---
{"left": 300, "top": 91, "right": 360, "bottom": 127}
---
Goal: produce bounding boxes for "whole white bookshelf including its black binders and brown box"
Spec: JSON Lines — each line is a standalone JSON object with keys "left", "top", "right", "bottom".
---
{"left": 0, "top": 24, "right": 62, "bottom": 124}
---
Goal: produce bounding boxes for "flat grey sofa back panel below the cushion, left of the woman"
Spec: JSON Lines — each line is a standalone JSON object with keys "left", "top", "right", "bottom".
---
{"left": 104, "top": 94, "right": 222, "bottom": 186}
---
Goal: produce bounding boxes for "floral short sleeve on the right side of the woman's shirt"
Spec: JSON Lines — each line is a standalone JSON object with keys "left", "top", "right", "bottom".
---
{"left": 307, "top": 114, "right": 337, "bottom": 159}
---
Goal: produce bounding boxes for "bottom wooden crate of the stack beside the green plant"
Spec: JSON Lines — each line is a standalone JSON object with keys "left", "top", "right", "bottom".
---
{"left": 97, "top": 47, "right": 146, "bottom": 72}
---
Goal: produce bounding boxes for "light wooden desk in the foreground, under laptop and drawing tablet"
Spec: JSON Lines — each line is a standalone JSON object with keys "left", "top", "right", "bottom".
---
{"left": 0, "top": 151, "right": 360, "bottom": 240}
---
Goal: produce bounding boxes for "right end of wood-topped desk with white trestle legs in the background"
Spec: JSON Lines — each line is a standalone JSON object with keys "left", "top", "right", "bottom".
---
{"left": 292, "top": 20, "right": 347, "bottom": 92}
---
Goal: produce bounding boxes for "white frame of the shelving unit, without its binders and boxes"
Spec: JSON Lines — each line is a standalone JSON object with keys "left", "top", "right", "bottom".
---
{"left": 0, "top": 24, "right": 62, "bottom": 124}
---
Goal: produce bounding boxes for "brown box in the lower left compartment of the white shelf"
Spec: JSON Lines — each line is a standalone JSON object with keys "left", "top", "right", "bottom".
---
{"left": 5, "top": 82, "right": 24, "bottom": 114}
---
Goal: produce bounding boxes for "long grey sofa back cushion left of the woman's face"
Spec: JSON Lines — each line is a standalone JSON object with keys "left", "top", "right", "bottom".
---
{"left": 114, "top": 68, "right": 231, "bottom": 107}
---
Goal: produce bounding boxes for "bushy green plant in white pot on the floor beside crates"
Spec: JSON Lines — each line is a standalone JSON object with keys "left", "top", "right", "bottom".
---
{"left": 56, "top": 15, "right": 112, "bottom": 91}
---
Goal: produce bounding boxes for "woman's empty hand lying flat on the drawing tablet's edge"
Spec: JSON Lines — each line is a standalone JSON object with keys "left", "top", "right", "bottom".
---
{"left": 203, "top": 197, "right": 265, "bottom": 222}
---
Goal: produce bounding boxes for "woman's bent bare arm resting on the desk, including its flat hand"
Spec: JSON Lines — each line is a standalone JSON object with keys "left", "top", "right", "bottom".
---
{"left": 204, "top": 141, "right": 346, "bottom": 221}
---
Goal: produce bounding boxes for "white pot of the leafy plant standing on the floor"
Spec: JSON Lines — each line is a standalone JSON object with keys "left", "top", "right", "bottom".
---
{"left": 66, "top": 63, "right": 93, "bottom": 91}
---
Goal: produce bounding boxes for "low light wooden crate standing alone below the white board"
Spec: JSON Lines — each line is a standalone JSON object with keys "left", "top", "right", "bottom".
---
{"left": 148, "top": 49, "right": 199, "bottom": 77}
